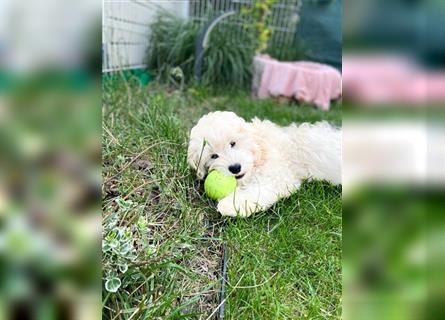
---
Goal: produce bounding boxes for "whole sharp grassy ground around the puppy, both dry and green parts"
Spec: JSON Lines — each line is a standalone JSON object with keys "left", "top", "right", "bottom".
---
{"left": 103, "top": 79, "right": 342, "bottom": 320}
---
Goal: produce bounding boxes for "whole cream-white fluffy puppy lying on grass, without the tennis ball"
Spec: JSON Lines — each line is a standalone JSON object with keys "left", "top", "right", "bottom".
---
{"left": 188, "top": 111, "right": 341, "bottom": 217}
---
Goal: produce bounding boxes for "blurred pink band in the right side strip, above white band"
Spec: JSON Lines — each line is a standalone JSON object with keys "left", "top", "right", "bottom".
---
{"left": 343, "top": 55, "right": 445, "bottom": 105}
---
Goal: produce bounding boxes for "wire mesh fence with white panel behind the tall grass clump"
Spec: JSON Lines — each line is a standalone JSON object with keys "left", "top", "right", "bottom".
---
{"left": 102, "top": 0, "right": 302, "bottom": 72}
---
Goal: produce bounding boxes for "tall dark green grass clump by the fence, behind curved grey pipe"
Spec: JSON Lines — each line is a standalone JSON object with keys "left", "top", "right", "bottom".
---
{"left": 147, "top": 13, "right": 254, "bottom": 87}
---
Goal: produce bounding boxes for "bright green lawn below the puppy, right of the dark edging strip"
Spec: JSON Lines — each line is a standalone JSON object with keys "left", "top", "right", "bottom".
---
{"left": 223, "top": 183, "right": 341, "bottom": 319}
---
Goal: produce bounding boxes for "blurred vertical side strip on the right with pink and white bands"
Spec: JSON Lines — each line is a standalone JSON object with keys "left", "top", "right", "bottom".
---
{"left": 343, "top": 0, "right": 445, "bottom": 320}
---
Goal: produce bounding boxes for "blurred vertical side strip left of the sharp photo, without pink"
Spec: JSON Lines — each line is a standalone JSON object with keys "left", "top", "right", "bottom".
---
{"left": 0, "top": 0, "right": 101, "bottom": 319}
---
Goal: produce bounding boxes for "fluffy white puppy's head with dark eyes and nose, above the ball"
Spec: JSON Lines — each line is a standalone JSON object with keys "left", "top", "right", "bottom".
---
{"left": 188, "top": 111, "right": 265, "bottom": 183}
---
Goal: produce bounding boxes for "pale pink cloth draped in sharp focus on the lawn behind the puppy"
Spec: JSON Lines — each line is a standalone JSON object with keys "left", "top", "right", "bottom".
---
{"left": 255, "top": 56, "right": 341, "bottom": 110}
